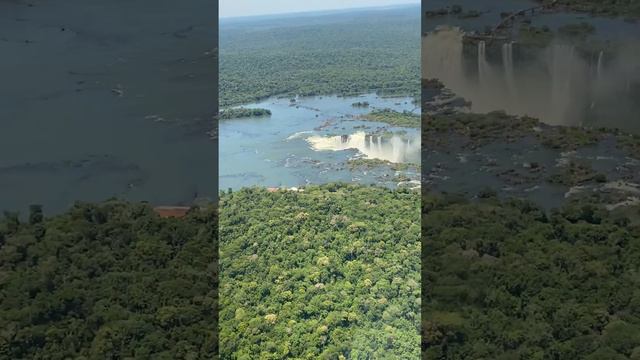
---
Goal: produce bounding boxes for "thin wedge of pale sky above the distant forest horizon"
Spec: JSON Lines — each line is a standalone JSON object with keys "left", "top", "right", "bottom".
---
{"left": 219, "top": 0, "right": 420, "bottom": 17}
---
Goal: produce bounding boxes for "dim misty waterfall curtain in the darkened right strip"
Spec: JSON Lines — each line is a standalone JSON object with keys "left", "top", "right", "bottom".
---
{"left": 422, "top": 27, "right": 640, "bottom": 128}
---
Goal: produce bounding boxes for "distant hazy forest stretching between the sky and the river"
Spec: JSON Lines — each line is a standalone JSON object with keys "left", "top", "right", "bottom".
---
{"left": 220, "top": 7, "right": 420, "bottom": 107}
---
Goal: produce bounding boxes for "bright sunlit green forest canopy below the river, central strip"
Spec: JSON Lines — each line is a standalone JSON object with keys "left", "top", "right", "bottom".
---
{"left": 220, "top": 184, "right": 420, "bottom": 359}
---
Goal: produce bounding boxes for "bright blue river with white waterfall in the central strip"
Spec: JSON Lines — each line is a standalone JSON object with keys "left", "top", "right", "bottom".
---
{"left": 219, "top": 94, "right": 420, "bottom": 189}
